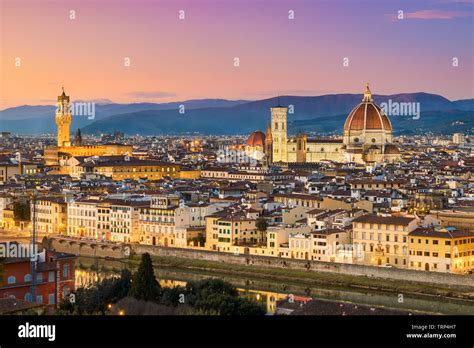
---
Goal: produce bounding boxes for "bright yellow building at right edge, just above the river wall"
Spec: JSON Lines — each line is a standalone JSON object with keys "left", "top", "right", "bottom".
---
{"left": 408, "top": 227, "right": 474, "bottom": 273}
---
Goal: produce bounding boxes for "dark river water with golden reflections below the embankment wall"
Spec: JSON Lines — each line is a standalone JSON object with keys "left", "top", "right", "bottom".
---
{"left": 76, "top": 257, "right": 474, "bottom": 315}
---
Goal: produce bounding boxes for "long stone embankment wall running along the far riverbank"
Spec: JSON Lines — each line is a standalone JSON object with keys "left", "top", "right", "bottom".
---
{"left": 43, "top": 237, "right": 474, "bottom": 291}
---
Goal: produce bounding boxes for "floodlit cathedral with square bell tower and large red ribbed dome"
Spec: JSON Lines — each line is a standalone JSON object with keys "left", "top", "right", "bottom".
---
{"left": 248, "top": 84, "right": 400, "bottom": 164}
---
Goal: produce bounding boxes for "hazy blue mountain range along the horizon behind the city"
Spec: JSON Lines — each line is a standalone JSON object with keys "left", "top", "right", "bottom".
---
{"left": 0, "top": 93, "right": 474, "bottom": 135}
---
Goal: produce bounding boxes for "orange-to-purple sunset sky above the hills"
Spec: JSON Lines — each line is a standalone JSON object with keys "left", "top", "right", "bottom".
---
{"left": 0, "top": 0, "right": 474, "bottom": 109}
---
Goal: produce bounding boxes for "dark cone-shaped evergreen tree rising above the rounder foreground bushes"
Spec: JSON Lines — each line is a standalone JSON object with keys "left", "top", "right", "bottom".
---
{"left": 128, "top": 253, "right": 161, "bottom": 302}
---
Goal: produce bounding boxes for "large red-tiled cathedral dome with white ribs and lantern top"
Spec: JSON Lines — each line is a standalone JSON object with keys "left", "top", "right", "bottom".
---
{"left": 344, "top": 84, "right": 392, "bottom": 132}
